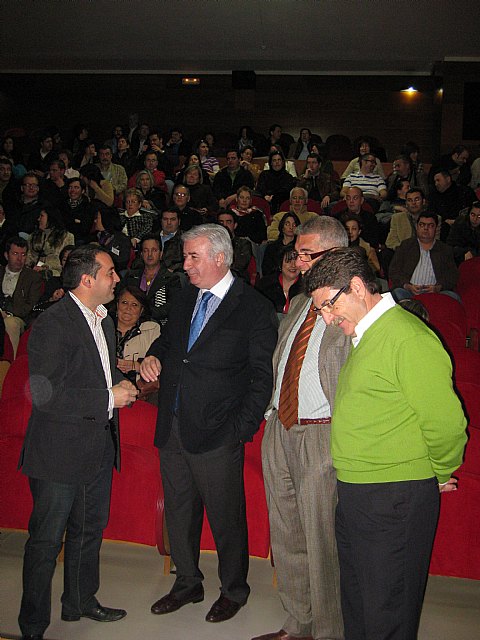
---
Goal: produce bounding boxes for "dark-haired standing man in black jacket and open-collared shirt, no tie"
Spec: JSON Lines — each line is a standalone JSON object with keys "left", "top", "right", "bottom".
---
{"left": 19, "top": 245, "right": 137, "bottom": 640}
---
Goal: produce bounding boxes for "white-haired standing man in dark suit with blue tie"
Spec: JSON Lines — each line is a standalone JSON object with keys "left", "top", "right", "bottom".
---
{"left": 140, "top": 224, "right": 276, "bottom": 622}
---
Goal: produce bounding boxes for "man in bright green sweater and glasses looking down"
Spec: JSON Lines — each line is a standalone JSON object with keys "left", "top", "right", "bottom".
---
{"left": 306, "top": 249, "right": 466, "bottom": 640}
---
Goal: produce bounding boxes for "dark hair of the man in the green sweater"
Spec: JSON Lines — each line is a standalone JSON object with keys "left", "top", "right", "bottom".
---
{"left": 305, "top": 248, "right": 378, "bottom": 295}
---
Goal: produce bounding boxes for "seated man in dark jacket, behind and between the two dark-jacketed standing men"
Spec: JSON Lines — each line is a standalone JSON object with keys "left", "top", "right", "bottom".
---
{"left": 122, "top": 236, "right": 183, "bottom": 325}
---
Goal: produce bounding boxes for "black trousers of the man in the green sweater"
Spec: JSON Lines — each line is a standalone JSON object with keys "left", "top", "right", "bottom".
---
{"left": 335, "top": 478, "right": 440, "bottom": 640}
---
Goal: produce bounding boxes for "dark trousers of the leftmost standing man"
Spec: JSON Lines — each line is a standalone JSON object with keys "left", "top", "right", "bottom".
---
{"left": 18, "top": 431, "right": 115, "bottom": 635}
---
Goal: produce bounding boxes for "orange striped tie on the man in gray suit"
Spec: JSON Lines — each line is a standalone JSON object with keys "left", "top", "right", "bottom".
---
{"left": 278, "top": 303, "right": 317, "bottom": 430}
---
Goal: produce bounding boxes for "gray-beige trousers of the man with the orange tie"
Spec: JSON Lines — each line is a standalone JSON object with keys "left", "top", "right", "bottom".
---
{"left": 262, "top": 411, "right": 343, "bottom": 640}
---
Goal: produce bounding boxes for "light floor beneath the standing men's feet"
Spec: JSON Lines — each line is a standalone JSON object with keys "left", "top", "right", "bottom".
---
{"left": 0, "top": 531, "right": 480, "bottom": 640}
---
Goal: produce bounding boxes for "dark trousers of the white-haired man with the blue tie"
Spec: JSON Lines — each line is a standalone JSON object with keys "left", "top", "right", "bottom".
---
{"left": 160, "top": 419, "right": 250, "bottom": 604}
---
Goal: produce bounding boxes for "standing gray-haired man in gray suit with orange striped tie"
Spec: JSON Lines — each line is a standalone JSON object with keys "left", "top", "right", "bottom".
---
{"left": 253, "top": 216, "right": 350, "bottom": 640}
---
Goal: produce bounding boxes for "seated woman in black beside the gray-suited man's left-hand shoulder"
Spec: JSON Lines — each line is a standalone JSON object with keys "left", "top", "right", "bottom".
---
{"left": 256, "top": 243, "right": 302, "bottom": 314}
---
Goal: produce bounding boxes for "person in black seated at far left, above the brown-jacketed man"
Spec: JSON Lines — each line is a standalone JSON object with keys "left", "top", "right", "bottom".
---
{"left": 8, "top": 171, "right": 44, "bottom": 235}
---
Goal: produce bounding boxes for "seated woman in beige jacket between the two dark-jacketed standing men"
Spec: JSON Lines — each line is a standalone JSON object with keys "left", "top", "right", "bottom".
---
{"left": 115, "top": 285, "right": 160, "bottom": 384}
